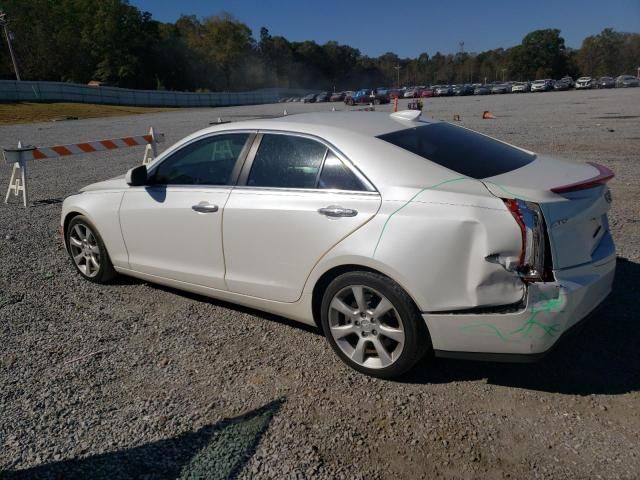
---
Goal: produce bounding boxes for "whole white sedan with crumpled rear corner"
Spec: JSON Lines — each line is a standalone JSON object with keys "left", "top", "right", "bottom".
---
{"left": 61, "top": 111, "right": 615, "bottom": 378}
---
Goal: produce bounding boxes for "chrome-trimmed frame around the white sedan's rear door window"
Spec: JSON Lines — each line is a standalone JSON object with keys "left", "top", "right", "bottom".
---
{"left": 236, "top": 129, "right": 379, "bottom": 194}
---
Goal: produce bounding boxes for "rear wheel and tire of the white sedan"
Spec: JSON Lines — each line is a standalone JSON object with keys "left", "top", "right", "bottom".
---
{"left": 321, "top": 272, "right": 431, "bottom": 378}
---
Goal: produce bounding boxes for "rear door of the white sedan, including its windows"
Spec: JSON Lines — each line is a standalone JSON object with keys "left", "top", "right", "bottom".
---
{"left": 223, "top": 132, "right": 380, "bottom": 302}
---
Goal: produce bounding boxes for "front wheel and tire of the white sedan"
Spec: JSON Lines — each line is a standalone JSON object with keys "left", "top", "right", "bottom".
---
{"left": 65, "top": 215, "right": 116, "bottom": 283}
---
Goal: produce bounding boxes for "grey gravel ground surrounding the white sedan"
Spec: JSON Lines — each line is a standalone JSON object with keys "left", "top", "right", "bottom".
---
{"left": 0, "top": 89, "right": 640, "bottom": 479}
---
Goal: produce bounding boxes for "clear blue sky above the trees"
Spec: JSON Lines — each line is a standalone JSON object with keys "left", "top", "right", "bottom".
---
{"left": 130, "top": 0, "right": 640, "bottom": 57}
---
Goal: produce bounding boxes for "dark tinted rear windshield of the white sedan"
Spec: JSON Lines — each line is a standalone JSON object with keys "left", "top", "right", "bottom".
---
{"left": 378, "top": 123, "right": 536, "bottom": 178}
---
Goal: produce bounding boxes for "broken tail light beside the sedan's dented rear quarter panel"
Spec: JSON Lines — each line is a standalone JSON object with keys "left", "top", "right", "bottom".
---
{"left": 503, "top": 199, "right": 553, "bottom": 282}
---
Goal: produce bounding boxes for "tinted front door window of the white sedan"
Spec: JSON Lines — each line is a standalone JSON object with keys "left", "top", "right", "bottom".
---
{"left": 151, "top": 133, "right": 249, "bottom": 185}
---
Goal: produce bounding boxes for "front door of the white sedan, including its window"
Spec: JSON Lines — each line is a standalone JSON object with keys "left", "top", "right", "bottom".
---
{"left": 120, "top": 132, "right": 255, "bottom": 290}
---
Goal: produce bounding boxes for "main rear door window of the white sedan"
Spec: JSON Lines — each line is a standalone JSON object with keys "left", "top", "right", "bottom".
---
{"left": 247, "top": 134, "right": 327, "bottom": 188}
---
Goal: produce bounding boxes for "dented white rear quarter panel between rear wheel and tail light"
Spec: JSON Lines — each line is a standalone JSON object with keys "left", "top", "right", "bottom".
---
{"left": 374, "top": 185, "right": 525, "bottom": 312}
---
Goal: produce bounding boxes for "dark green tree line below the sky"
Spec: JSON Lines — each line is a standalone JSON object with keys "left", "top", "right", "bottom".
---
{"left": 0, "top": 0, "right": 640, "bottom": 91}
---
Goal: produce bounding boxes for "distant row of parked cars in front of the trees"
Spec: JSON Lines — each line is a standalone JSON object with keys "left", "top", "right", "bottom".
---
{"left": 280, "top": 75, "right": 640, "bottom": 105}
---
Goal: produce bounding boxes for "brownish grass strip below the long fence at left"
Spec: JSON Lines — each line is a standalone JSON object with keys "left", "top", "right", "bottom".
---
{"left": 0, "top": 102, "right": 177, "bottom": 125}
